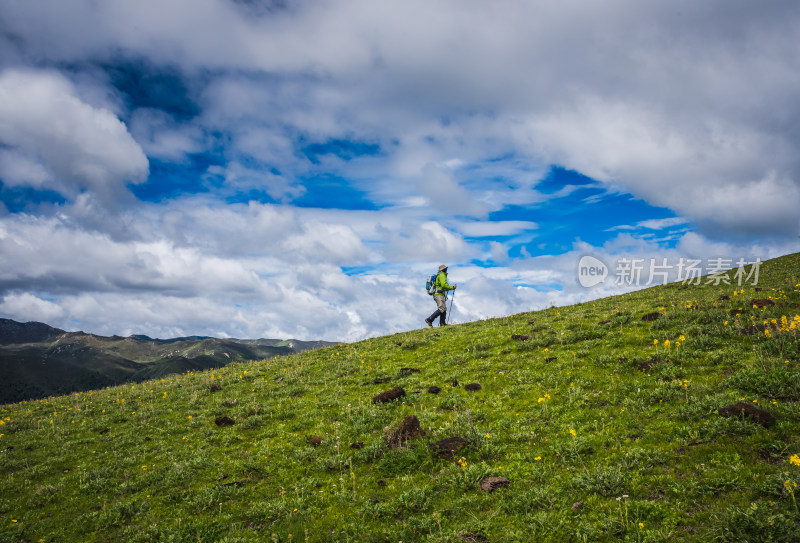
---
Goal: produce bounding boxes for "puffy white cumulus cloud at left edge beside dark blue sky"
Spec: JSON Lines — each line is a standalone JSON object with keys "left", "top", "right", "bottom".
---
{"left": 0, "top": 69, "right": 148, "bottom": 201}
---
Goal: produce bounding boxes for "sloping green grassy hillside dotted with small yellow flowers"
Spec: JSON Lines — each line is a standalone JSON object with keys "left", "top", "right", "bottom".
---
{"left": 0, "top": 254, "right": 800, "bottom": 543}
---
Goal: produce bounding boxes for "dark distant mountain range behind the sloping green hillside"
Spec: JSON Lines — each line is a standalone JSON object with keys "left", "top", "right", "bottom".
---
{"left": 0, "top": 319, "right": 337, "bottom": 404}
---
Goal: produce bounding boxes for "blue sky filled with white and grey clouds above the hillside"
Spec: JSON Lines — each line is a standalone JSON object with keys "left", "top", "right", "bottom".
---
{"left": 0, "top": 0, "right": 800, "bottom": 341}
